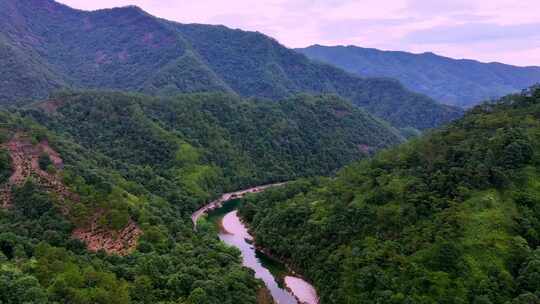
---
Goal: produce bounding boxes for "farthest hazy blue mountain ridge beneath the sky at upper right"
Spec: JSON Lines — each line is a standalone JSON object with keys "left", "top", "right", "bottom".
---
{"left": 297, "top": 45, "right": 540, "bottom": 108}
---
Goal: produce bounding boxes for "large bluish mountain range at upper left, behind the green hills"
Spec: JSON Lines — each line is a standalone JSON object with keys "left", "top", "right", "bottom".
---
{"left": 0, "top": 0, "right": 462, "bottom": 129}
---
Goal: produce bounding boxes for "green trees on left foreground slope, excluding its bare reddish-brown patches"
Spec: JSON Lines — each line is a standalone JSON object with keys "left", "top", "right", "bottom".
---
{"left": 0, "top": 103, "right": 261, "bottom": 304}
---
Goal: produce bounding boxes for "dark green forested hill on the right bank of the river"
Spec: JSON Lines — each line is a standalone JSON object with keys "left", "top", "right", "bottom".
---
{"left": 240, "top": 88, "right": 540, "bottom": 303}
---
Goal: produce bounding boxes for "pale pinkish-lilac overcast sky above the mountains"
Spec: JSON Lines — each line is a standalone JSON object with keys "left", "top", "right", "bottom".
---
{"left": 59, "top": 0, "right": 540, "bottom": 66}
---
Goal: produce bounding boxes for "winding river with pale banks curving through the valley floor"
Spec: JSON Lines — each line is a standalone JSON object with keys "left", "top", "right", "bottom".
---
{"left": 191, "top": 183, "right": 319, "bottom": 304}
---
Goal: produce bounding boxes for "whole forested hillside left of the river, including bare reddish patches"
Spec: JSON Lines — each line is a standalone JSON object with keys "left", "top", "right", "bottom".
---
{"left": 0, "top": 91, "right": 403, "bottom": 304}
